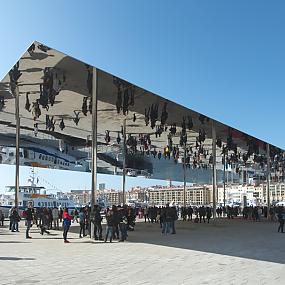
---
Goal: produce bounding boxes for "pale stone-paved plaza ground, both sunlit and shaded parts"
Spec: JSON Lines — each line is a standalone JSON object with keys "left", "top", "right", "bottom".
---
{"left": 0, "top": 219, "right": 285, "bottom": 285}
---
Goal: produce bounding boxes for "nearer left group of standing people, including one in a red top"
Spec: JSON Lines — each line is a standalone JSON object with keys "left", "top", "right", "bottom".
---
{"left": 0, "top": 203, "right": 136, "bottom": 243}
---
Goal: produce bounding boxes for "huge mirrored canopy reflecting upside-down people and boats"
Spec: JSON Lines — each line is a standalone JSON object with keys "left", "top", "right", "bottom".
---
{"left": 0, "top": 42, "right": 284, "bottom": 184}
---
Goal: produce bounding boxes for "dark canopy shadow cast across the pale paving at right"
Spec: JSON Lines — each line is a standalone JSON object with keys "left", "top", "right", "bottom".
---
{"left": 125, "top": 219, "right": 285, "bottom": 264}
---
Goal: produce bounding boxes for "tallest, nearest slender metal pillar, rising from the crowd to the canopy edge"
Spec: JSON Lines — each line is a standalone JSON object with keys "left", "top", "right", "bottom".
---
{"left": 90, "top": 68, "right": 98, "bottom": 238}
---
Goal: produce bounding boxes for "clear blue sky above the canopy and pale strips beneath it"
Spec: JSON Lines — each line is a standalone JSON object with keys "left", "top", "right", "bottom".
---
{"left": 0, "top": 0, "right": 285, "bottom": 191}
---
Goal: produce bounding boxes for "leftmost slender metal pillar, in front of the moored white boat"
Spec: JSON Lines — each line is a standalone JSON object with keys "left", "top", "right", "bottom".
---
{"left": 14, "top": 85, "right": 20, "bottom": 207}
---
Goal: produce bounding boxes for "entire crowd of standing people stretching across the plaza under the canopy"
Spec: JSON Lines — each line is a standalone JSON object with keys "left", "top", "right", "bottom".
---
{"left": 0, "top": 203, "right": 285, "bottom": 240}
